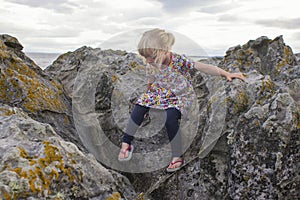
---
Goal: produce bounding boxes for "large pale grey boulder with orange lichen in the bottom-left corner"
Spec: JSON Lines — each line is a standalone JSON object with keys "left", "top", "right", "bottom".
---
{"left": 0, "top": 105, "right": 134, "bottom": 200}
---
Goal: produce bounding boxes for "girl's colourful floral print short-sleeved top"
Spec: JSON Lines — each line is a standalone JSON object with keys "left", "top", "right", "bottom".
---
{"left": 136, "top": 53, "right": 194, "bottom": 114}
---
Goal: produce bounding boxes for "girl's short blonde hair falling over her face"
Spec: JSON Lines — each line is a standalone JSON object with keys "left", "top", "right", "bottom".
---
{"left": 138, "top": 28, "right": 175, "bottom": 64}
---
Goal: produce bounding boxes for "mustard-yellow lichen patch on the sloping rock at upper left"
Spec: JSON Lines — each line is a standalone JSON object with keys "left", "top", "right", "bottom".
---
{"left": 0, "top": 58, "right": 66, "bottom": 112}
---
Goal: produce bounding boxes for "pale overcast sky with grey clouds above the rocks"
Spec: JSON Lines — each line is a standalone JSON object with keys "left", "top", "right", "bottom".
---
{"left": 0, "top": 0, "right": 300, "bottom": 56}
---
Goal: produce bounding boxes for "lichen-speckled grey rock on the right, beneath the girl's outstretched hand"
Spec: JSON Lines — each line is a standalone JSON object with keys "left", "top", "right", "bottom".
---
{"left": 221, "top": 36, "right": 300, "bottom": 199}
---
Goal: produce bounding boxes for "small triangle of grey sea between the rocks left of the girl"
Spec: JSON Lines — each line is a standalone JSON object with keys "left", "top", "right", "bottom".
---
{"left": 25, "top": 52, "right": 61, "bottom": 69}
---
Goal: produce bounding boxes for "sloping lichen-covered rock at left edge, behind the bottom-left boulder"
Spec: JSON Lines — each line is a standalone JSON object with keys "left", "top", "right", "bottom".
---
{"left": 0, "top": 35, "right": 84, "bottom": 149}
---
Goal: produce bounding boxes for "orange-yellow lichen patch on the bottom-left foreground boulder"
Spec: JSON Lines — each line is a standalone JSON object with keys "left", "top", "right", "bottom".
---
{"left": 5, "top": 141, "right": 82, "bottom": 199}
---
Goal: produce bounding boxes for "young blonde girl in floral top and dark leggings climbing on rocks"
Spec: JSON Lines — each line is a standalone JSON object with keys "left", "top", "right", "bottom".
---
{"left": 118, "top": 29, "right": 245, "bottom": 172}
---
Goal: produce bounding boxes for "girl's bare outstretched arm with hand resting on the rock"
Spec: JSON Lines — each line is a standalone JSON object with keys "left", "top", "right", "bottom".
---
{"left": 195, "top": 62, "right": 245, "bottom": 81}
